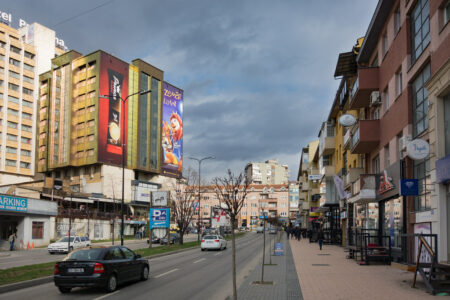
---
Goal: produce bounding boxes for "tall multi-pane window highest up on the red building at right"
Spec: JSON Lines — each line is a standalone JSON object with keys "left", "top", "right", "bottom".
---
{"left": 411, "top": 0, "right": 430, "bottom": 63}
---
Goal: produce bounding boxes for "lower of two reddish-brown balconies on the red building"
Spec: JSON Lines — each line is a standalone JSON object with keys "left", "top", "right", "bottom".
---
{"left": 351, "top": 120, "right": 380, "bottom": 154}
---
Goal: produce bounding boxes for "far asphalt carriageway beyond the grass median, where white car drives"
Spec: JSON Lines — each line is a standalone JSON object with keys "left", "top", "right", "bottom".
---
{"left": 0, "top": 234, "right": 197, "bottom": 269}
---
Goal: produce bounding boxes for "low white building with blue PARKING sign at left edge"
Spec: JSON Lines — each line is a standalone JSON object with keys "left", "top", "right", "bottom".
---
{"left": 0, "top": 195, "right": 58, "bottom": 250}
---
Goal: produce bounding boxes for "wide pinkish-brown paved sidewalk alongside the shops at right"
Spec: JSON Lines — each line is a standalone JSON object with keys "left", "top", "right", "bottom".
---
{"left": 290, "top": 239, "right": 436, "bottom": 300}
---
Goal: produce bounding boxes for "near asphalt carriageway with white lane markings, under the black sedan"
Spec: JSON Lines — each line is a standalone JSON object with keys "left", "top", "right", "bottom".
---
{"left": 1, "top": 233, "right": 263, "bottom": 300}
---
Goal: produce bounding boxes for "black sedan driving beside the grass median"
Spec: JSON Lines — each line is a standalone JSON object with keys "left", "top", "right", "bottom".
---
{"left": 53, "top": 246, "right": 150, "bottom": 293}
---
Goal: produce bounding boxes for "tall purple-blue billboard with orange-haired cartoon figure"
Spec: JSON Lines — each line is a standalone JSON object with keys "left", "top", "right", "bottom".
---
{"left": 161, "top": 82, "right": 183, "bottom": 178}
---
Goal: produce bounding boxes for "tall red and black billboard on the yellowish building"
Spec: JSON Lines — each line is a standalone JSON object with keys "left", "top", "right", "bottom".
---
{"left": 98, "top": 52, "right": 128, "bottom": 165}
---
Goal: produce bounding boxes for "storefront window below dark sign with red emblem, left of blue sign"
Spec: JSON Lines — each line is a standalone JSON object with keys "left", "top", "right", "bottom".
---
{"left": 383, "top": 198, "right": 403, "bottom": 248}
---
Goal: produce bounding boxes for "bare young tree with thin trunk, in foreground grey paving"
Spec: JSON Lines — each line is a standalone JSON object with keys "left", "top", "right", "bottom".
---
{"left": 213, "top": 169, "right": 250, "bottom": 300}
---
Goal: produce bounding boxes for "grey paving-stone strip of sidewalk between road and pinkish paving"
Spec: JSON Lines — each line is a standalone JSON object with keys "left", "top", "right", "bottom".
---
{"left": 238, "top": 233, "right": 303, "bottom": 300}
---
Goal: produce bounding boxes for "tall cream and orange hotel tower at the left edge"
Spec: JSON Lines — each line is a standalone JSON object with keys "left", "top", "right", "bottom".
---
{"left": 0, "top": 23, "right": 64, "bottom": 185}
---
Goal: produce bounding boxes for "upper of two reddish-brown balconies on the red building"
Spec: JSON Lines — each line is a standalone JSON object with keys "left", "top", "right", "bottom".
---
{"left": 350, "top": 67, "right": 379, "bottom": 109}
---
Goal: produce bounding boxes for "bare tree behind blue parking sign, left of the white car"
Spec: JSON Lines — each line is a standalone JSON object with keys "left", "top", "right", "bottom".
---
{"left": 172, "top": 168, "right": 196, "bottom": 245}
